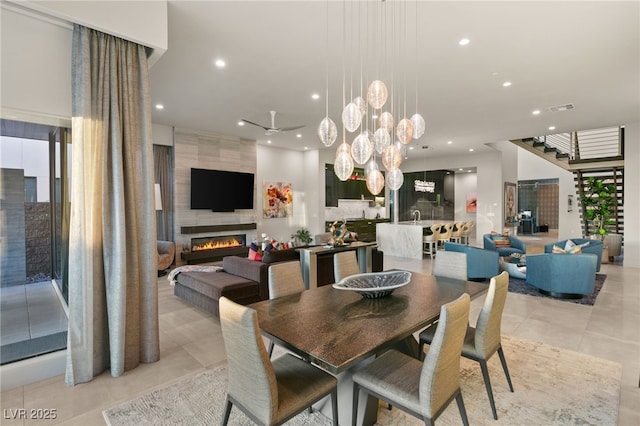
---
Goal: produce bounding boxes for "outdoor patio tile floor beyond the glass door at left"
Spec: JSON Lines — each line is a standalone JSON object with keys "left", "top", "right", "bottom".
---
{"left": 0, "top": 281, "right": 67, "bottom": 345}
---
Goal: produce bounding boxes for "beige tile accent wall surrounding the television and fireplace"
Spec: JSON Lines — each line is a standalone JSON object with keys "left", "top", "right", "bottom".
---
{"left": 174, "top": 129, "right": 258, "bottom": 265}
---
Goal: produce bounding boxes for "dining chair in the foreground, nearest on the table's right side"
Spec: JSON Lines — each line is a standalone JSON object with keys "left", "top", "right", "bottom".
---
{"left": 352, "top": 292, "right": 471, "bottom": 426}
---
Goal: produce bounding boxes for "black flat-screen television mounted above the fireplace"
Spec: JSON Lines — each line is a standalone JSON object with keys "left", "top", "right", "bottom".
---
{"left": 191, "top": 169, "right": 254, "bottom": 212}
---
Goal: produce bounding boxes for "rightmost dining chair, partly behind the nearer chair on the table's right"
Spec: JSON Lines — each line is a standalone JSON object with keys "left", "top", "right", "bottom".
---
{"left": 419, "top": 271, "right": 513, "bottom": 420}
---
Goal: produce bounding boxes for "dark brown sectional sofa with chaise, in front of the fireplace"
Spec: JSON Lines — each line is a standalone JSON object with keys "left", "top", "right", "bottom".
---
{"left": 174, "top": 248, "right": 383, "bottom": 317}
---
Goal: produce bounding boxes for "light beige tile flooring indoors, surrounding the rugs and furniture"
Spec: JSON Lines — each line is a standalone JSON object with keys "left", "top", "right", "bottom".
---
{"left": 2, "top": 234, "right": 640, "bottom": 426}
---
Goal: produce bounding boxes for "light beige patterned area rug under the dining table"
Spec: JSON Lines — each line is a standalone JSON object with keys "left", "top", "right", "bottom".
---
{"left": 103, "top": 336, "right": 622, "bottom": 426}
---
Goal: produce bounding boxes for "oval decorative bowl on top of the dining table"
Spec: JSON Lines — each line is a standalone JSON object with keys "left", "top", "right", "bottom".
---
{"left": 333, "top": 271, "right": 411, "bottom": 299}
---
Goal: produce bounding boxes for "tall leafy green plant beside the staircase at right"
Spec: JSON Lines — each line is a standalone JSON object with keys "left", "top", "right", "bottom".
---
{"left": 580, "top": 176, "right": 618, "bottom": 239}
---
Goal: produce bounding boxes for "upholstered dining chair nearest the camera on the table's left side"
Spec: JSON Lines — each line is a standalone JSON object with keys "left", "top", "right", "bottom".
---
{"left": 219, "top": 297, "right": 338, "bottom": 426}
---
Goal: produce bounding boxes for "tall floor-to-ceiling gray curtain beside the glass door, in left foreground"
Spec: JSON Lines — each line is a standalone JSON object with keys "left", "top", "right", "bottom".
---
{"left": 65, "top": 25, "right": 160, "bottom": 385}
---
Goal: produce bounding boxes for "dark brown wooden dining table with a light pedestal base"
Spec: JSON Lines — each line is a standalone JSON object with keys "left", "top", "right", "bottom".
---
{"left": 250, "top": 272, "right": 488, "bottom": 425}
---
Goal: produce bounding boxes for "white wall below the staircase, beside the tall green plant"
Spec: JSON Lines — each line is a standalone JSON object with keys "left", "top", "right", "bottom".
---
{"left": 518, "top": 149, "right": 583, "bottom": 240}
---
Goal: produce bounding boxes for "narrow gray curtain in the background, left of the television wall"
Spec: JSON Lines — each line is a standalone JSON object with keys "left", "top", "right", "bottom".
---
{"left": 153, "top": 145, "right": 174, "bottom": 241}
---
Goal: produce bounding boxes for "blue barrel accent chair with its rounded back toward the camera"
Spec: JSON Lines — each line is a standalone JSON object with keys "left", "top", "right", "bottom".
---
{"left": 527, "top": 253, "right": 598, "bottom": 299}
